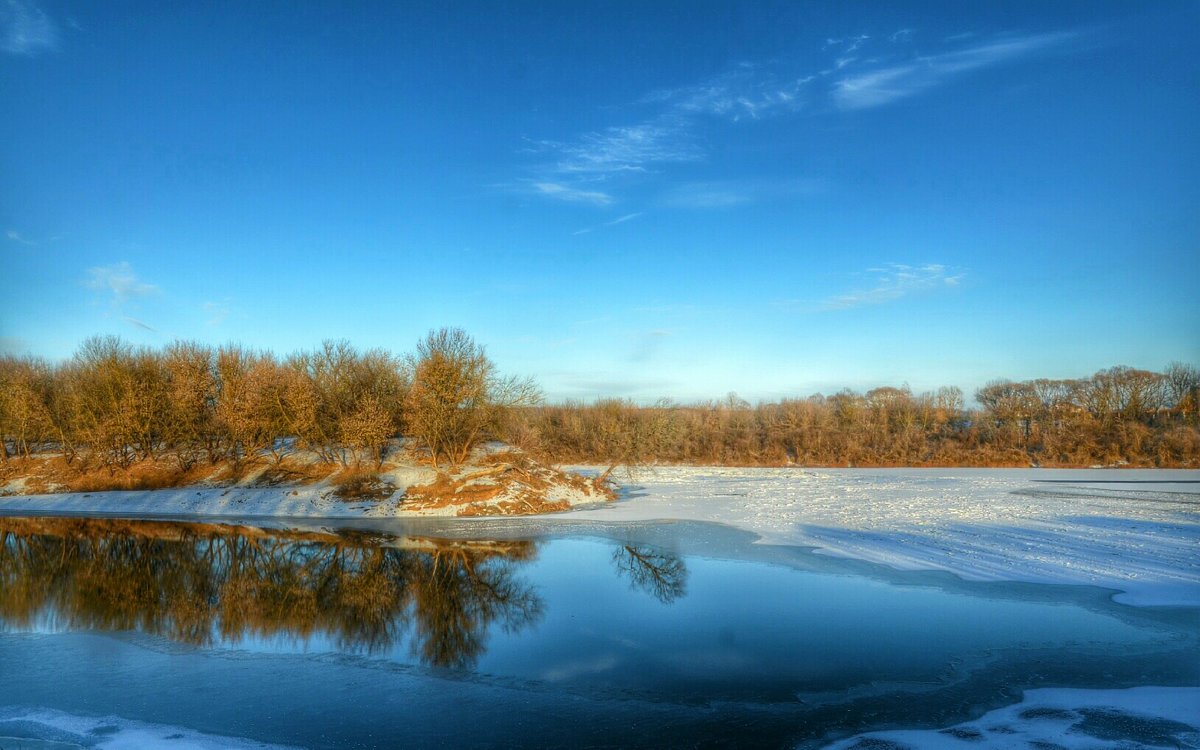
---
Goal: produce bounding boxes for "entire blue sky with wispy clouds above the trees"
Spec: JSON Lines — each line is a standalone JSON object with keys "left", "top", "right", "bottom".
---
{"left": 0, "top": 0, "right": 1200, "bottom": 401}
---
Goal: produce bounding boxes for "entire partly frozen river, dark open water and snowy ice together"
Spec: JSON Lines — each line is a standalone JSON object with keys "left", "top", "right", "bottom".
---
{"left": 0, "top": 468, "right": 1200, "bottom": 750}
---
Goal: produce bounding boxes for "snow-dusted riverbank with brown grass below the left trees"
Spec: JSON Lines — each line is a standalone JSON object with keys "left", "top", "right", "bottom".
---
{"left": 0, "top": 445, "right": 613, "bottom": 518}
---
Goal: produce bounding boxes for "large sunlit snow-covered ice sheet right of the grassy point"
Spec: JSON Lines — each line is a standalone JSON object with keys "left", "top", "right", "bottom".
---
{"left": 559, "top": 467, "right": 1200, "bottom": 606}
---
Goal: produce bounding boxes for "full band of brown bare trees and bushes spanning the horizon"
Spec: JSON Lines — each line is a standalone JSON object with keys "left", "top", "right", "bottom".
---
{"left": 0, "top": 329, "right": 1200, "bottom": 473}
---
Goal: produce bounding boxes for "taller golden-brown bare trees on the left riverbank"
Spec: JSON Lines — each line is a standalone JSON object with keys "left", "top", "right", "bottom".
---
{"left": 0, "top": 329, "right": 538, "bottom": 470}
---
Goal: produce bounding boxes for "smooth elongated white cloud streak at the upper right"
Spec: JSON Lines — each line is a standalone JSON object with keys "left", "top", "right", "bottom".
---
{"left": 833, "top": 32, "right": 1075, "bottom": 109}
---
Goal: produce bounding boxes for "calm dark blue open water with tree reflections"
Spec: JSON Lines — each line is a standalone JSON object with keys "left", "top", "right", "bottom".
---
{"left": 0, "top": 518, "right": 1200, "bottom": 748}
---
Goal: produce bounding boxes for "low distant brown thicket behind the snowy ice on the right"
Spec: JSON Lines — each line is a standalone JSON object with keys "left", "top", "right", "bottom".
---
{"left": 517, "top": 366, "right": 1200, "bottom": 467}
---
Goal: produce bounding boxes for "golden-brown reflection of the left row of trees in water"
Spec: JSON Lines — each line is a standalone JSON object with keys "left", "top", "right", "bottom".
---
{"left": 0, "top": 518, "right": 544, "bottom": 667}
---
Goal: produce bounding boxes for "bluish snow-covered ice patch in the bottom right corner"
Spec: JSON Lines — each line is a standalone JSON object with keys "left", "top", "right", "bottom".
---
{"left": 828, "top": 688, "right": 1200, "bottom": 750}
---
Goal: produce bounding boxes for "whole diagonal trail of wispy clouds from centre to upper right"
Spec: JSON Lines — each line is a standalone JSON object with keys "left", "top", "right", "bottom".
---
{"left": 526, "top": 28, "right": 1078, "bottom": 206}
